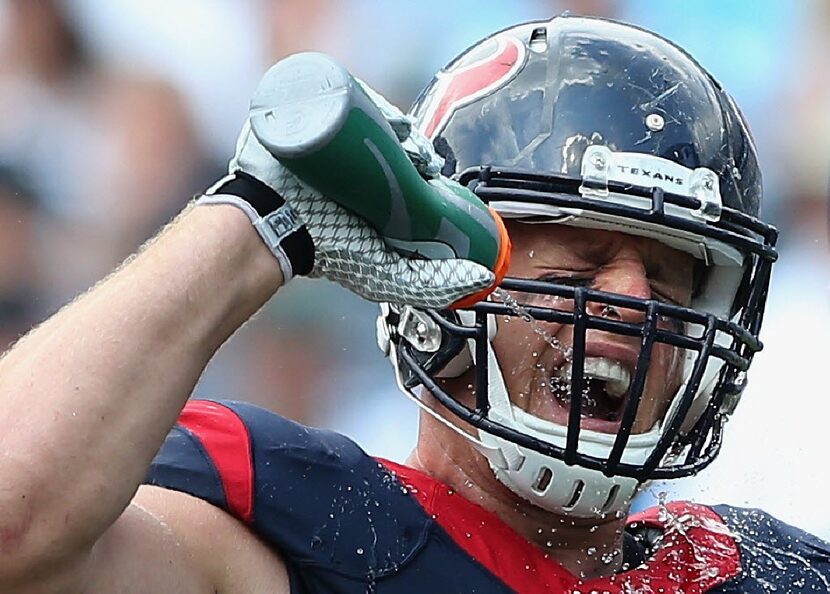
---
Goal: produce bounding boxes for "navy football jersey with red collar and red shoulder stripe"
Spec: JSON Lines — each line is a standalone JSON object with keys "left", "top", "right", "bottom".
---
{"left": 146, "top": 400, "right": 830, "bottom": 594}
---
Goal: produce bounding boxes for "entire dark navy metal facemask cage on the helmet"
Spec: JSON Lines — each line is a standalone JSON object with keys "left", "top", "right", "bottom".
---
{"left": 390, "top": 167, "right": 777, "bottom": 480}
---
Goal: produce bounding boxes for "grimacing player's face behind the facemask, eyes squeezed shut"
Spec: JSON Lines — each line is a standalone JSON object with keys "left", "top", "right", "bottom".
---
{"left": 494, "top": 222, "right": 694, "bottom": 433}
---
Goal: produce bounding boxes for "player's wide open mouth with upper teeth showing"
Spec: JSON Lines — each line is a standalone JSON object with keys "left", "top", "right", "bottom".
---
{"left": 550, "top": 357, "right": 631, "bottom": 428}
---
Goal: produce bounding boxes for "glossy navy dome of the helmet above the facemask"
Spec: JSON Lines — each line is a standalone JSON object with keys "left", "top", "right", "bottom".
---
{"left": 412, "top": 16, "right": 762, "bottom": 216}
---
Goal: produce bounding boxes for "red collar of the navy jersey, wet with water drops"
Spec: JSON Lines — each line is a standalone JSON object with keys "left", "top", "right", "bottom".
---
{"left": 379, "top": 460, "right": 741, "bottom": 594}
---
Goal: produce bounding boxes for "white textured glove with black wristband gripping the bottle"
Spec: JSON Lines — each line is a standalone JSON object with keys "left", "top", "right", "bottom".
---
{"left": 198, "top": 118, "right": 495, "bottom": 309}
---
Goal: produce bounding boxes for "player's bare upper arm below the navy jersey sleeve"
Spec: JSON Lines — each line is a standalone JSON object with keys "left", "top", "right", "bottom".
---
{"left": 82, "top": 487, "right": 289, "bottom": 594}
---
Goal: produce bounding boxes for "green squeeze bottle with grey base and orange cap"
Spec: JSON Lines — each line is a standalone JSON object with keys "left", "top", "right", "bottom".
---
{"left": 250, "top": 53, "right": 510, "bottom": 292}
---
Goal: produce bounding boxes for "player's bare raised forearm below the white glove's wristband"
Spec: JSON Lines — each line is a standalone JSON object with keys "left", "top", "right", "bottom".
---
{"left": 0, "top": 205, "right": 282, "bottom": 559}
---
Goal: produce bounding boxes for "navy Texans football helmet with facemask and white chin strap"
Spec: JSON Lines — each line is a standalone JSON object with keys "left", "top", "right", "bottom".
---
{"left": 379, "top": 16, "right": 777, "bottom": 517}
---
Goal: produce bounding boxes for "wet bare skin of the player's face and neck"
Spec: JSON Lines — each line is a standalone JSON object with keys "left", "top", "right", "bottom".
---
{"left": 407, "top": 222, "right": 694, "bottom": 578}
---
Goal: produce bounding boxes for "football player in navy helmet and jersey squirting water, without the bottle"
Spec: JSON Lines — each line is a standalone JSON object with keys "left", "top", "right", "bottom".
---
{"left": 0, "top": 12, "right": 830, "bottom": 594}
